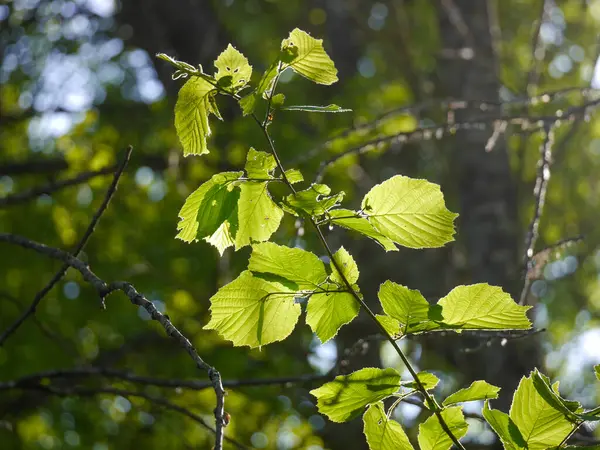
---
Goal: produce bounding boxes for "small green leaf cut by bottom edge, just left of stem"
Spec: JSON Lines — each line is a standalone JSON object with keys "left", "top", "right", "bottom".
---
{"left": 363, "top": 402, "right": 413, "bottom": 450}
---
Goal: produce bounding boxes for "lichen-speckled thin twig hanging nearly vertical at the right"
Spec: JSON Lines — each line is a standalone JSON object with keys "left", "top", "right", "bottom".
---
{"left": 519, "top": 127, "right": 554, "bottom": 305}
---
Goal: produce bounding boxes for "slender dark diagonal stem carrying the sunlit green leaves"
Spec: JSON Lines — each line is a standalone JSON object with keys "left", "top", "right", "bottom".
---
{"left": 252, "top": 113, "right": 465, "bottom": 450}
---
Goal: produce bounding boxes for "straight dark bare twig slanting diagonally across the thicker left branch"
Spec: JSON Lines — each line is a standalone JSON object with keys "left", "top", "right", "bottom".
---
{"left": 0, "top": 146, "right": 133, "bottom": 347}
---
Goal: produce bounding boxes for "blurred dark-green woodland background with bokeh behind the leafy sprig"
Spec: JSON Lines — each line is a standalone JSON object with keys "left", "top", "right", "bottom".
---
{"left": 0, "top": 0, "right": 600, "bottom": 450}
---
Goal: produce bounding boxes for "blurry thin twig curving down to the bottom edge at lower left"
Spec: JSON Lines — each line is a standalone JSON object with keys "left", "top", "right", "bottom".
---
{"left": 2, "top": 384, "right": 248, "bottom": 449}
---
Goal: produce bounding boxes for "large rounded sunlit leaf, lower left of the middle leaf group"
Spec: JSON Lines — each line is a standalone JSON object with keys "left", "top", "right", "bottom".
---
{"left": 204, "top": 271, "right": 300, "bottom": 347}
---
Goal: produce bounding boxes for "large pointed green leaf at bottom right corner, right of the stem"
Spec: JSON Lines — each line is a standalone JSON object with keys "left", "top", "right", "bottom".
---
{"left": 509, "top": 376, "right": 575, "bottom": 450}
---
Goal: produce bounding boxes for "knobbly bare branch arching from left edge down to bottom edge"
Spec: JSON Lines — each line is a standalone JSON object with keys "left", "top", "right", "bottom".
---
{"left": 0, "top": 233, "right": 225, "bottom": 450}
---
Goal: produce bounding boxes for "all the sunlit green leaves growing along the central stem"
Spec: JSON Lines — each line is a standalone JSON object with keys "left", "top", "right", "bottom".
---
{"left": 159, "top": 29, "right": 597, "bottom": 450}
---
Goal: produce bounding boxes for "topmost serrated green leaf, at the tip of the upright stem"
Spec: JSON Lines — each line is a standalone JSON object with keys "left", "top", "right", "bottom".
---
{"left": 281, "top": 28, "right": 338, "bottom": 84}
